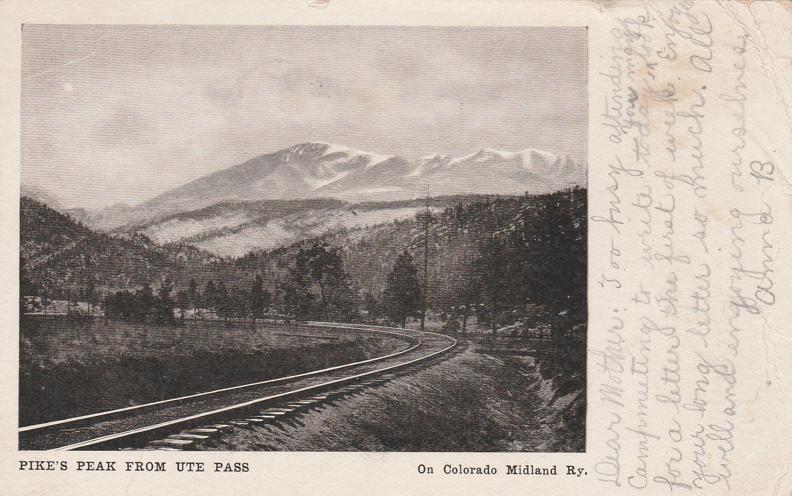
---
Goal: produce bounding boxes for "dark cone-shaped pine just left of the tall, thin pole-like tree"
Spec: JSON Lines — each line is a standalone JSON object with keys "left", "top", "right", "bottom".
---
{"left": 385, "top": 251, "right": 422, "bottom": 327}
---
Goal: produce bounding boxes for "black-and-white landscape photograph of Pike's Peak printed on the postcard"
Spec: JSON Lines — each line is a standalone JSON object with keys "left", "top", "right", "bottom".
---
{"left": 18, "top": 24, "right": 588, "bottom": 454}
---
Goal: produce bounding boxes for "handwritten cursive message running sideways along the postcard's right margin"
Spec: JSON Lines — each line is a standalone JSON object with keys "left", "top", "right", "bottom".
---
{"left": 588, "top": 0, "right": 782, "bottom": 494}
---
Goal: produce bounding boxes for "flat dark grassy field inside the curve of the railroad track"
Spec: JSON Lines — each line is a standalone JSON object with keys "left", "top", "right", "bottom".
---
{"left": 19, "top": 317, "right": 408, "bottom": 425}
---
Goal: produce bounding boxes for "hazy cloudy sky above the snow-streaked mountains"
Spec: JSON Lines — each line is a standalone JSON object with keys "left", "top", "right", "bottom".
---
{"left": 22, "top": 25, "right": 586, "bottom": 208}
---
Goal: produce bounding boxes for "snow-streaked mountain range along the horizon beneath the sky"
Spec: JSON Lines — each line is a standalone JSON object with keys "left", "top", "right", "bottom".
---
{"left": 57, "top": 142, "right": 586, "bottom": 231}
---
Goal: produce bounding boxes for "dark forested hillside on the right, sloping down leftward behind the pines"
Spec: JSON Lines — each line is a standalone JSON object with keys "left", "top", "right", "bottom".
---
{"left": 235, "top": 188, "right": 587, "bottom": 332}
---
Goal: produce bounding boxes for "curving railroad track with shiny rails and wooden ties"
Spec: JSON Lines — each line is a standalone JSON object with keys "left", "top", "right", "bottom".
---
{"left": 19, "top": 322, "right": 457, "bottom": 450}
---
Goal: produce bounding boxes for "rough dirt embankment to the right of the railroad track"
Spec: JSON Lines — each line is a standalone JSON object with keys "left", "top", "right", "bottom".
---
{"left": 209, "top": 347, "right": 585, "bottom": 452}
